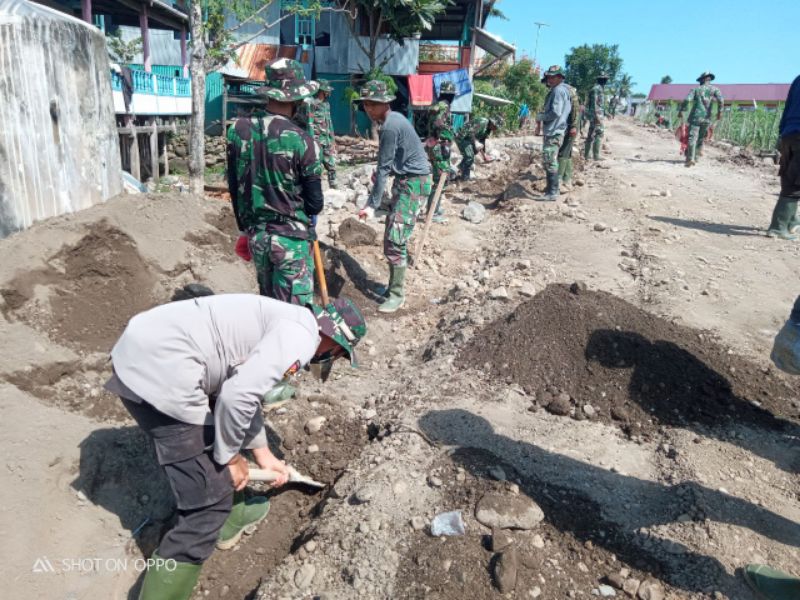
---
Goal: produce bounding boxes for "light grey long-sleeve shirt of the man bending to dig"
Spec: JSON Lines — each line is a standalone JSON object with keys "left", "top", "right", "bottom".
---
{"left": 107, "top": 294, "right": 320, "bottom": 465}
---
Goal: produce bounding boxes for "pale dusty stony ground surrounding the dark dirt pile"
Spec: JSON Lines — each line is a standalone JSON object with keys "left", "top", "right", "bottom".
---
{"left": 0, "top": 119, "right": 800, "bottom": 600}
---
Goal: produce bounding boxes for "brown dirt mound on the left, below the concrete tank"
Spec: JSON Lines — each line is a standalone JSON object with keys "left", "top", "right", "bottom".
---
{"left": 0, "top": 221, "right": 156, "bottom": 351}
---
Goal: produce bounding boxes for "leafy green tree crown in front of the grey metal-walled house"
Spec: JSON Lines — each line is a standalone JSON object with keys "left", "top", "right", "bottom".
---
{"left": 337, "top": 0, "right": 452, "bottom": 73}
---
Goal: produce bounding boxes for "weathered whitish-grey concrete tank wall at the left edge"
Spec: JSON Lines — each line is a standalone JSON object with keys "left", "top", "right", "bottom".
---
{"left": 0, "top": 0, "right": 122, "bottom": 237}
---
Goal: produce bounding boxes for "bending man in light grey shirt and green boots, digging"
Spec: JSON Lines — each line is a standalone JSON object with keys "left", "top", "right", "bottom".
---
{"left": 106, "top": 294, "right": 367, "bottom": 600}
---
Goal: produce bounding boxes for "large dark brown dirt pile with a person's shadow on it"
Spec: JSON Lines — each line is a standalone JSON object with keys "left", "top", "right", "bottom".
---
{"left": 458, "top": 284, "right": 798, "bottom": 435}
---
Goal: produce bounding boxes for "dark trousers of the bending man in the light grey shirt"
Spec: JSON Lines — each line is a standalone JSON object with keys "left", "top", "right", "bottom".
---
{"left": 122, "top": 398, "right": 233, "bottom": 564}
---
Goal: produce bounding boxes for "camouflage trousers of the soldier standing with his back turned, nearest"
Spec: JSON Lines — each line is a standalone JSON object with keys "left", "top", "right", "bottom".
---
{"left": 250, "top": 231, "right": 314, "bottom": 306}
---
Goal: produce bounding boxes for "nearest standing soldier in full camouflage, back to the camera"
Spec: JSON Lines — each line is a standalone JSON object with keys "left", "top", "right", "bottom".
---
{"left": 228, "top": 58, "right": 324, "bottom": 305}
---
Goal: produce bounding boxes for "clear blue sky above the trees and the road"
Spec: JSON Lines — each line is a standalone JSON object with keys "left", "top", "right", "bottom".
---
{"left": 487, "top": 0, "right": 800, "bottom": 93}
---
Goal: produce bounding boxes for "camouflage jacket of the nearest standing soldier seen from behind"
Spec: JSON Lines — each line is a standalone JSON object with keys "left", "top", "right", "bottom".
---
{"left": 228, "top": 112, "right": 322, "bottom": 239}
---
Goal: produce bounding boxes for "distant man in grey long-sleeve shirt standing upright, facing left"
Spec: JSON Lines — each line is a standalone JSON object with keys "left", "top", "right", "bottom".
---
{"left": 536, "top": 65, "right": 572, "bottom": 201}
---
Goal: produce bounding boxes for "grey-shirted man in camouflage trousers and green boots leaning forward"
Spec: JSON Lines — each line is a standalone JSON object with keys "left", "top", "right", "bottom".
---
{"left": 358, "top": 81, "right": 431, "bottom": 313}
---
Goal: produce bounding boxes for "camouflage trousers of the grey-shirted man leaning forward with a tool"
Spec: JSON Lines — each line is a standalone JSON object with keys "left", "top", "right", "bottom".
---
{"left": 383, "top": 175, "right": 431, "bottom": 267}
